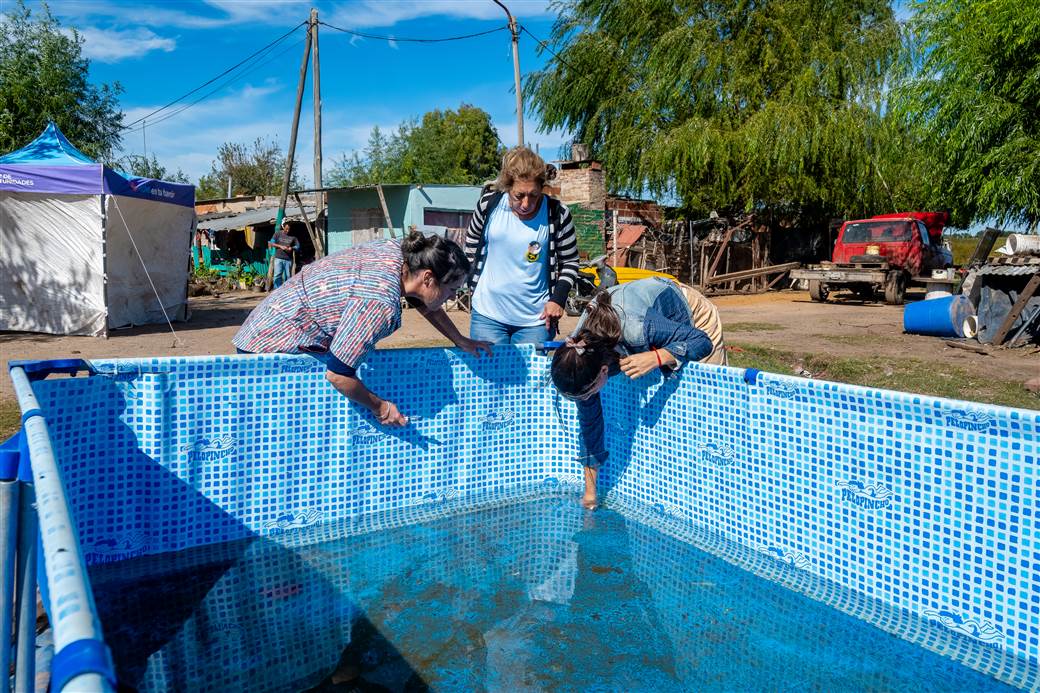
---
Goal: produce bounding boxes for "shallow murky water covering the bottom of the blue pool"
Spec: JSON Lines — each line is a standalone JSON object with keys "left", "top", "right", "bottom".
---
{"left": 92, "top": 493, "right": 1012, "bottom": 691}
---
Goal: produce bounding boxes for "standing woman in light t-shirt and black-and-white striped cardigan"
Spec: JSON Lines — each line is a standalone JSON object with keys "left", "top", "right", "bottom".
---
{"left": 466, "top": 147, "right": 578, "bottom": 344}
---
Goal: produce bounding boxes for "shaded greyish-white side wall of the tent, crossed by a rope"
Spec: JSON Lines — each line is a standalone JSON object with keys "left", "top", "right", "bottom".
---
{"left": 105, "top": 196, "right": 194, "bottom": 328}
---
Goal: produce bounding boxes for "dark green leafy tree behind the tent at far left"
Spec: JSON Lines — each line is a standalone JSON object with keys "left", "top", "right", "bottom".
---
{"left": 0, "top": 0, "right": 123, "bottom": 160}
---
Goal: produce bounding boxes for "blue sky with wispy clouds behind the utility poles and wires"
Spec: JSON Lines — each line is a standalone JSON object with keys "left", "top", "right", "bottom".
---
{"left": 40, "top": 0, "right": 566, "bottom": 182}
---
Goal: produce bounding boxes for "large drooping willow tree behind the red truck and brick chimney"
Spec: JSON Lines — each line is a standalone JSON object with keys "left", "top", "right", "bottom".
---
{"left": 526, "top": 0, "right": 916, "bottom": 217}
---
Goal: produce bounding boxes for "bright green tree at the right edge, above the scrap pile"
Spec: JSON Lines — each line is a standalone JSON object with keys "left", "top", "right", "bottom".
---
{"left": 896, "top": 0, "right": 1040, "bottom": 225}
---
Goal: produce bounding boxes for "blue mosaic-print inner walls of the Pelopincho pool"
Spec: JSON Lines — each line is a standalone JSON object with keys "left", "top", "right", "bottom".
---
{"left": 28, "top": 349, "right": 1040, "bottom": 663}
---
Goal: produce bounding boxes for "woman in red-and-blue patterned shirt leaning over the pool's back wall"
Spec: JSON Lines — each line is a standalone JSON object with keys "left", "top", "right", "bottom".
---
{"left": 232, "top": 232, "right": 491, "bottom": 426}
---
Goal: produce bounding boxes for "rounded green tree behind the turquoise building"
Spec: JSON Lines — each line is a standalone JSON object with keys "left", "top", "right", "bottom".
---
{"left": 329, "top": 104, "right": 501, "bottom": 185}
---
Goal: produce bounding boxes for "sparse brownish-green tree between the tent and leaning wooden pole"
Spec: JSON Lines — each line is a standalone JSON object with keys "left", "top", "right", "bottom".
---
{"left": 196, "top": 137, "right": 301, "bottom": 200}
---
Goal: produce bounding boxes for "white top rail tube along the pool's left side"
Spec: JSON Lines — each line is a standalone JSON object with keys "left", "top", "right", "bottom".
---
{"left": 10, "top": 368, "right": 110, "bottom": 693}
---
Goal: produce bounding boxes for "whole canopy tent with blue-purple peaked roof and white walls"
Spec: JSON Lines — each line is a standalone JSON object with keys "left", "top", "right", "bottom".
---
{"left": 0, "top": 123, "right": 196, "bottom": 336}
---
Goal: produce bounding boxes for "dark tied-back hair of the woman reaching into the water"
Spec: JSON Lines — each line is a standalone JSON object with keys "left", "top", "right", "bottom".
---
{"left": 552, "top": 291, "right": 621, "bottom": 396}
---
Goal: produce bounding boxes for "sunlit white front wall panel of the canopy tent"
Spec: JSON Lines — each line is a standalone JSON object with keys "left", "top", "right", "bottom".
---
{"left": 0, "top": 191, "right": 106, "bottom": 335}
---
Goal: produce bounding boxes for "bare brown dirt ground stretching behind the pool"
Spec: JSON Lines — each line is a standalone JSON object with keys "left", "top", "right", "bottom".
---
{"left": 0, "top": 291, "right": 1040, "bottom": 408}
